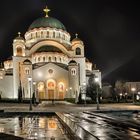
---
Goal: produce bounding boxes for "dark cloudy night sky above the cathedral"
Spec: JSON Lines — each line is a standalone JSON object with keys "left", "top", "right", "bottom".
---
{"left": 0, "top": 0, "right": 140, "bottom": 82}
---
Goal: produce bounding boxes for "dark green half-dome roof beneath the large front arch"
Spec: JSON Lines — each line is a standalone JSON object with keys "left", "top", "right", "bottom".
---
{"left": 36, "top": 46, "right": 62, "bottom": 53}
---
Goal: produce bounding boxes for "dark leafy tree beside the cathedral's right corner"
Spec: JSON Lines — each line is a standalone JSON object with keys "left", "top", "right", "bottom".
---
{"left": 87, "top": 74, "right": 102, "bottom": 101}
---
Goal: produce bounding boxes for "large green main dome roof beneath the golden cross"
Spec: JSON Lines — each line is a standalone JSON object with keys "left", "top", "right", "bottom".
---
{"left": 29, "top": 17, "right": 66, "bottom": 30}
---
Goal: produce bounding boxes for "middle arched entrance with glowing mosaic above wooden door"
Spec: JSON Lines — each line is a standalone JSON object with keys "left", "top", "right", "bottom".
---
{"left": 47, "top": 79, "right": 56, "bottom": 100}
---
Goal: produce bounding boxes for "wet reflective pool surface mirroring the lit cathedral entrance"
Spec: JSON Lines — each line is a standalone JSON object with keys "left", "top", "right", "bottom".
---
{"left": 0, "top": 116, "right": 67, "bottom": 140}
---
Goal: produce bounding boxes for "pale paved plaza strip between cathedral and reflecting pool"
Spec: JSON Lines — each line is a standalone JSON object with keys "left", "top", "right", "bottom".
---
{"left": 0, "top": 102, "right": 140, "bottom": 112}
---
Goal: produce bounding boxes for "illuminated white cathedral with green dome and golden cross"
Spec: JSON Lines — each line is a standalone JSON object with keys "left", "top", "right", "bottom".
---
{"left": 0, "top": 7, "right": 101, "bottom": 102}
